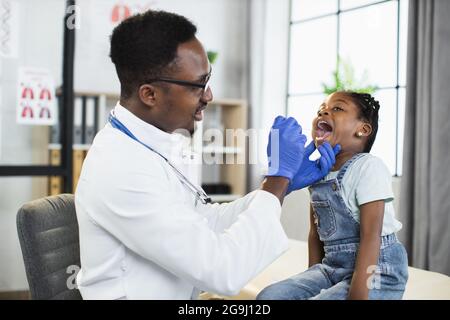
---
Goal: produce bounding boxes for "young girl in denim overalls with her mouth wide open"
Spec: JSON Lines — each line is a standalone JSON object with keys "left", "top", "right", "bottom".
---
{"left": 257, "top": 91, "right": 408, "bottom": 300}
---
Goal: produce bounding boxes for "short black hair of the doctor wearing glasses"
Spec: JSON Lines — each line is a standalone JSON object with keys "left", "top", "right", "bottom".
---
{"left": 110, "top": 10, "right": 197, "bottom": 98}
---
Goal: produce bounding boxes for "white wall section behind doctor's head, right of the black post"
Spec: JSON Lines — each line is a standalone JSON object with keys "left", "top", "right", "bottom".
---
{"left": 75, "top": 0, "right": 247, "bottom": 98}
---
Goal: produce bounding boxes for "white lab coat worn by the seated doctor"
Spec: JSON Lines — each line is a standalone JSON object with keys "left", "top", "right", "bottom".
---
{"left": 75, "top": 105, "right": 288, "bottom": 299}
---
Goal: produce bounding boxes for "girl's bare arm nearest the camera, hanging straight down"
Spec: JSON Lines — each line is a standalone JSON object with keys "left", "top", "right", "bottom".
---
{"left": 348, "top": 200, "right": 384, "bottom": 300}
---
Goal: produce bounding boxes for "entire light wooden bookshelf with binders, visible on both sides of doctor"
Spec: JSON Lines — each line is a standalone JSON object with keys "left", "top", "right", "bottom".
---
{"left": 48, "top": 92, "right": 247, "bottom": 202}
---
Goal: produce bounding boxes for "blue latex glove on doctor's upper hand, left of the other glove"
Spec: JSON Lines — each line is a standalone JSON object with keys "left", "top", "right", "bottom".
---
{"left": 266, "top": 116, "right": 306, "bottom": 182}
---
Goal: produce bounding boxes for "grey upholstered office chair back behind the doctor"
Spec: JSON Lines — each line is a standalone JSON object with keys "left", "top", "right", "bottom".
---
{"left": 17, "top": 194, "right": 82, "bottom": 300}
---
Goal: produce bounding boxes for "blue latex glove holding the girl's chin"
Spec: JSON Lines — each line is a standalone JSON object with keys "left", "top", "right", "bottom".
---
{"left": 286, "top": 141, "right": 341, "bottom": 194}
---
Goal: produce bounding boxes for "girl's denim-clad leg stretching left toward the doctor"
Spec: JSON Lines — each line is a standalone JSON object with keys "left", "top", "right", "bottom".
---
{"left": 256, "top": 264, "right": 332, "bottom": 300}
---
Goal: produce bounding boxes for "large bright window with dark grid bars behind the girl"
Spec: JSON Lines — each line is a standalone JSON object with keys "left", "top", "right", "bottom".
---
{"left": 286, "top": 0, "right": 408, "bottom": 175}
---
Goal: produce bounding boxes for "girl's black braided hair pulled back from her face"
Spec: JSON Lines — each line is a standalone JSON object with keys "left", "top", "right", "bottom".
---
{"left": 340, "top": 91, "right": 380, "bottom": 152}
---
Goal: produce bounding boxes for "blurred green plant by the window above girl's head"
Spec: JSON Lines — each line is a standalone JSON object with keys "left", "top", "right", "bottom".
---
{"left": 322, "top": 57, "right": 378, "bottom": 95}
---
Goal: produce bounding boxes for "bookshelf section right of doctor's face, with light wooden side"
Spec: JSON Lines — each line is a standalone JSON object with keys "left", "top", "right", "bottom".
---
{"left": 198, "top": 99, "right": 248, "bottom": 202}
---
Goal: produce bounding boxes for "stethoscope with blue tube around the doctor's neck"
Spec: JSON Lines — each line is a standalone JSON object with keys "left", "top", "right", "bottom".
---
{"left": 108, "top": 110, "right": 211, "bottom": 204}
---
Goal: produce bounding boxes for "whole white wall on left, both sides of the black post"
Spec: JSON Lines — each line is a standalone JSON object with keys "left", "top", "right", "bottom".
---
{"left": 0, "top": 0, "right": 247, "bottom": 291}
